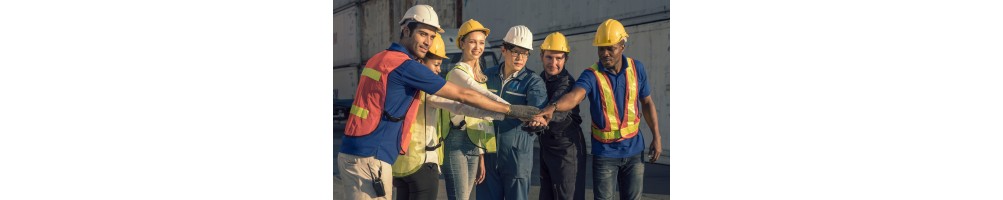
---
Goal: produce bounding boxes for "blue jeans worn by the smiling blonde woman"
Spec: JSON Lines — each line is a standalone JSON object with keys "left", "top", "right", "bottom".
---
{"left": 442, "top": 129, "right": 480, "bottom": 200}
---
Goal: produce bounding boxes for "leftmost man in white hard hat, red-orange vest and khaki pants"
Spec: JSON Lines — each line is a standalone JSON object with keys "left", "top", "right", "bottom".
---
{"left": 338, "top": 5, "right": 540, "bottom": 199}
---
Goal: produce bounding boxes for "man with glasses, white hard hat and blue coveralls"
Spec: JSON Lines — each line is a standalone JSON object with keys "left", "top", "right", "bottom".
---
{"left": 476, "top": 25, "right": 547, "bottom": 199}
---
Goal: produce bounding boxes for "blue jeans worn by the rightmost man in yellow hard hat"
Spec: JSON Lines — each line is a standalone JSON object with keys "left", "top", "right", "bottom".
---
{"left": 592, "top": 152, "right": 644, "bottom": 199}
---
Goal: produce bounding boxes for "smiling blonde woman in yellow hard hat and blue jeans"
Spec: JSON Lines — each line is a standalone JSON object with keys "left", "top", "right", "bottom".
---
{"left": 442, "top": 19, "right": 508, "bottom": 200}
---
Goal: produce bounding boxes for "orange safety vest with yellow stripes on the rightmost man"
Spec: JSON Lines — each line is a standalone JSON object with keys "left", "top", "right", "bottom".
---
{"left": 586, "top": 57, "right": 641, "bottom": 144}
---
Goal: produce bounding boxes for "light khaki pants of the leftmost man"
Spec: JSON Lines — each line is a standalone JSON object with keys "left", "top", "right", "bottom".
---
{"left": 338, "top": 153, "right": 393, "bottom": 199}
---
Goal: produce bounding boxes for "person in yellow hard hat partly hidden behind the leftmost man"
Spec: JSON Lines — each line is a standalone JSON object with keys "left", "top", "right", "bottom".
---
{"left": 393, "top": 34, "right": 505, "bottom": 200}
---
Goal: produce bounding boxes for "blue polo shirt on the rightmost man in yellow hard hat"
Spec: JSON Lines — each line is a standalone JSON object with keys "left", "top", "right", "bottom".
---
{"left": 575, "top": 55, "right": 651, "bottom": 158}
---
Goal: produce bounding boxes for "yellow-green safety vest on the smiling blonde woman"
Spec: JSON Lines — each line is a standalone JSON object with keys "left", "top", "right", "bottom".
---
{"left": 442, "top": 64, "right": 497, "bottom": 153}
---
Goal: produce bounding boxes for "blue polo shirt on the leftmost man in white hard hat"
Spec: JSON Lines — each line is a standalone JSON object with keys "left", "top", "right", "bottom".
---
{"left": 340, "top": 43, "right": 445, "bottom": 165}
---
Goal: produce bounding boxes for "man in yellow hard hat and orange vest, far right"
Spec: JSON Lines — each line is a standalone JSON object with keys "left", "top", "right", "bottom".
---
{"left": 541, "top": 19, "right": 662, "bottom": 199}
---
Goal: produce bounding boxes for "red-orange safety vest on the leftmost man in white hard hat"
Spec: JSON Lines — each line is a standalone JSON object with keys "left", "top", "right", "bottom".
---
{"left": 345, "top": 50, "right": 421, "bottom": 155}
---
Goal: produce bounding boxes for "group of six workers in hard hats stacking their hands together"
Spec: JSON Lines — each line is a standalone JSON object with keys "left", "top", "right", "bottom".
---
{"left": 337, "top": 5, "right": 662, "bottom": 200}
